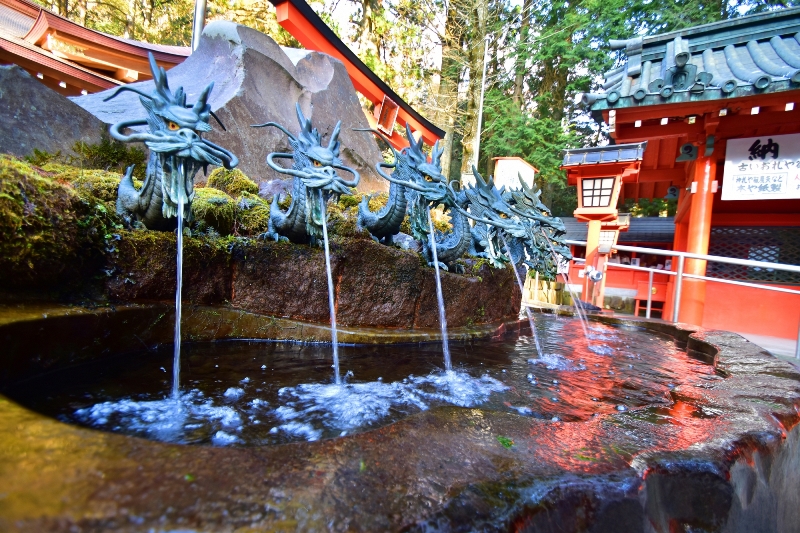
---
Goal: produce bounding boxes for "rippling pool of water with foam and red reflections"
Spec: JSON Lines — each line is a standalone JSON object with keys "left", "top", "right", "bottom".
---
{"left": 5, "top": 316, "right": 716, "bottom": 446}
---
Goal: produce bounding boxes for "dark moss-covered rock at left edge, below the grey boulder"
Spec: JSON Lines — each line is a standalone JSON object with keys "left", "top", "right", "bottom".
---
{"left": 0, "top": 155, "right": 121, "bottom": 289}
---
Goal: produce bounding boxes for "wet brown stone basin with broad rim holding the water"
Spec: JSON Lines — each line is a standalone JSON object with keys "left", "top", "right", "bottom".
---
{"left": 0, "top": 306, "right": 800, "bottom": 532}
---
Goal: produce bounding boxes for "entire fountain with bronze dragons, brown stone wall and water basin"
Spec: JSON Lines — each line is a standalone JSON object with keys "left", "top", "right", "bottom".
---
{"left": 0, "top": 30, "right": 800, "bottom": 533}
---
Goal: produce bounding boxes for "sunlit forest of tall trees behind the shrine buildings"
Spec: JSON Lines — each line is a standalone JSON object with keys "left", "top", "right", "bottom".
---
{"left": 36, "top": 0, "right": 797, "bottom": 216}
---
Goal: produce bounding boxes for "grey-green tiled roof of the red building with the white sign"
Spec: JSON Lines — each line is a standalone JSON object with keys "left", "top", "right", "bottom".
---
{"left": 582, "top": 8, "right": 800, "bottom": 112}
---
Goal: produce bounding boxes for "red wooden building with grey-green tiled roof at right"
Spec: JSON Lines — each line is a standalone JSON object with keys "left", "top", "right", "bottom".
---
{"left": 563, "top": 9, "right": 800, "bottom": 339}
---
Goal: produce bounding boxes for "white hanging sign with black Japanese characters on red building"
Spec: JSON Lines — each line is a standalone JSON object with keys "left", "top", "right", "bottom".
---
{"left": 722, "top": 134, "right": 800, "bottom": 200}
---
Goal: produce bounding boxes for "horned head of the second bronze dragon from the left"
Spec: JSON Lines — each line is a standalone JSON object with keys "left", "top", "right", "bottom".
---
{"left": 253, "top": 104, "right": 360, "bottom": 195}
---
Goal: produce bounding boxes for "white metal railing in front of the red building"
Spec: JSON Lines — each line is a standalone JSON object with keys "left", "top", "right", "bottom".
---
{"left": 566, "top": 241, "right": 800, "bottom": 359}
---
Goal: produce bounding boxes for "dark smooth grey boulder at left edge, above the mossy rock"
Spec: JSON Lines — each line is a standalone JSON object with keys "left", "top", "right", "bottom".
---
{"left": 0, "top": 65, "right": 108, "bottom": 157}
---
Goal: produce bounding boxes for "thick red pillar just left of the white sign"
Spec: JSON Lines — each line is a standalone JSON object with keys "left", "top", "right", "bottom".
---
{"left": 675, "top": 157, "right": 717, "bottom": 326}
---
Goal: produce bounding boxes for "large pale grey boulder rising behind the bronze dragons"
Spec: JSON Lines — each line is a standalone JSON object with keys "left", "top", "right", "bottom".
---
{"left": 72, "top": 21, "right": 388, "bottom": 191}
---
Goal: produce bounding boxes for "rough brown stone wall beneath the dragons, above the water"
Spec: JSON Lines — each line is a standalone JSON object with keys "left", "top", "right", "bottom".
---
{"left": 105, "top": 232, "right": 520, "bottom": 329}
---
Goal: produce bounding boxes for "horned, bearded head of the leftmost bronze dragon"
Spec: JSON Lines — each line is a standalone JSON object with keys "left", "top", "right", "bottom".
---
{"left": 104, "top": 53, "right": 239, "bottom": 218}
